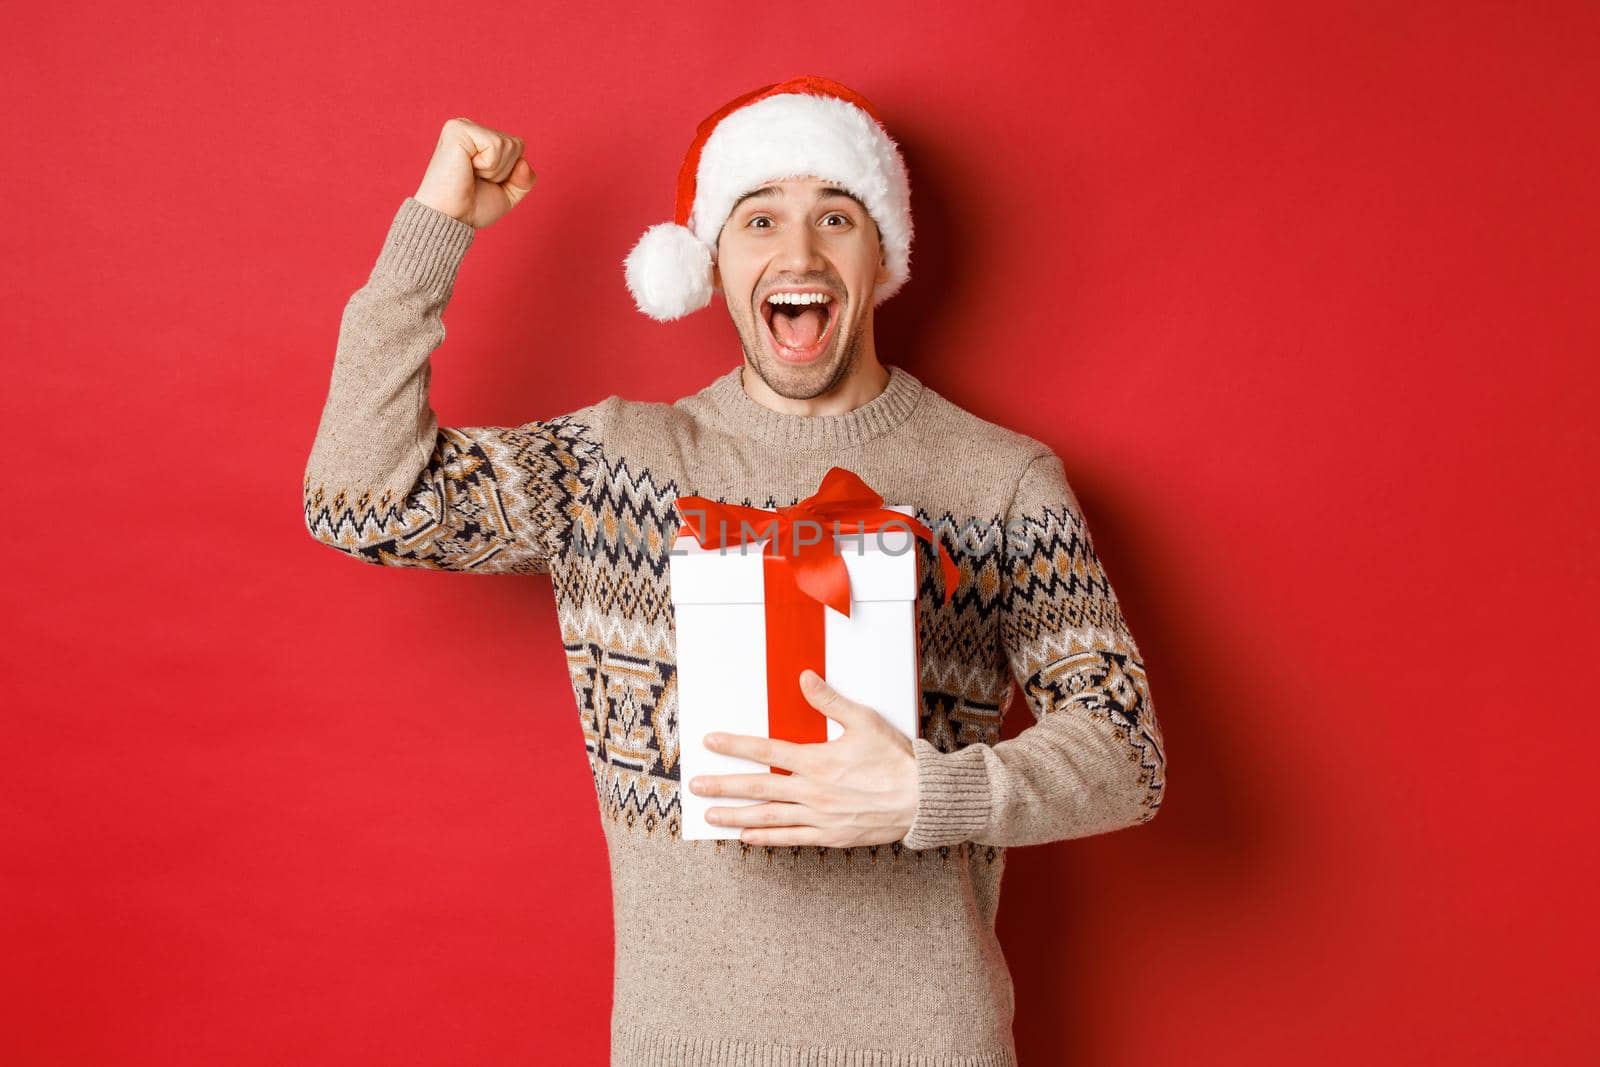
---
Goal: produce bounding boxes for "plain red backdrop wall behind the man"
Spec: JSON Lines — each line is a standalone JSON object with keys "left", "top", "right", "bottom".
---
{"left": 0, "top": 2, "right": 1600, "bottom": 1067}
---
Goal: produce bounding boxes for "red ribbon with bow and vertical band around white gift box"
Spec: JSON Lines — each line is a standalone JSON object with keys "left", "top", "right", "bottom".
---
{"left": 677, "top": 467, "right": 960, "bottom": 774}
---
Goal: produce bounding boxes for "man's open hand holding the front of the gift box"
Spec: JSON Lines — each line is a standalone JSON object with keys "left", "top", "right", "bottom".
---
{"left": 688, "top": 669, "right": 917, "bottom": 848}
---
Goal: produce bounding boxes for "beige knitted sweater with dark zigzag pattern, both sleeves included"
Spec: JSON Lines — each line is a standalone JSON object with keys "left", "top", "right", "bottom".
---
{"left": 304, "top": 198, "right": 1165, "bottom": 1067}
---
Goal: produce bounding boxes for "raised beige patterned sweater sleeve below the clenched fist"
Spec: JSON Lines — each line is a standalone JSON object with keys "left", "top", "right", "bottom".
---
{"left": 304, "top": 197, "right": 606, "bottom": 573}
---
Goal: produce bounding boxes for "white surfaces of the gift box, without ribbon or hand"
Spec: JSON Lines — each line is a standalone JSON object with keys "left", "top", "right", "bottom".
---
{"left": 667, "top": 506, "right": 922, "bottom": 840}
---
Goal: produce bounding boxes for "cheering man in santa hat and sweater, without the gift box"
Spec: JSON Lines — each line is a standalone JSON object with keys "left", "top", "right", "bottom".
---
{"left": 304, "top": 77, "right": 1166, "bottom": 1067}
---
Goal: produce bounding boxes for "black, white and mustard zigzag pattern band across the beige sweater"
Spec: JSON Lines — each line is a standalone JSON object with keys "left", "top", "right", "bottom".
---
{"left": 306, "top": 399, "right": 1163, "bottom": 862}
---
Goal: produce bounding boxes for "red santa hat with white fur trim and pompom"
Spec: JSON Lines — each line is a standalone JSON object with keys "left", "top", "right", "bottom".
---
{"left": 622, "top": 75, "right": 912, "bottom": 322}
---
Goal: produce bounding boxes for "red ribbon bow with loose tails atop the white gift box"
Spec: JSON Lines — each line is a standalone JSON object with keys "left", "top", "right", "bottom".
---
{"left": 677, "top": 467, "right": 960, "bottom": 616}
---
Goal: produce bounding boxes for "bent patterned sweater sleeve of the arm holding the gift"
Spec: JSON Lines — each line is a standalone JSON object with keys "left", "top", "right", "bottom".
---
{"left": 902, "top": 453, "right": 1166, "bottom": 848}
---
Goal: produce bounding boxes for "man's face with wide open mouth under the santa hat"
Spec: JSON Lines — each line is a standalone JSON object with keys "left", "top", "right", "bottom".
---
{"left": 714, "top": 178, "right": 888, "bottom": 400}
